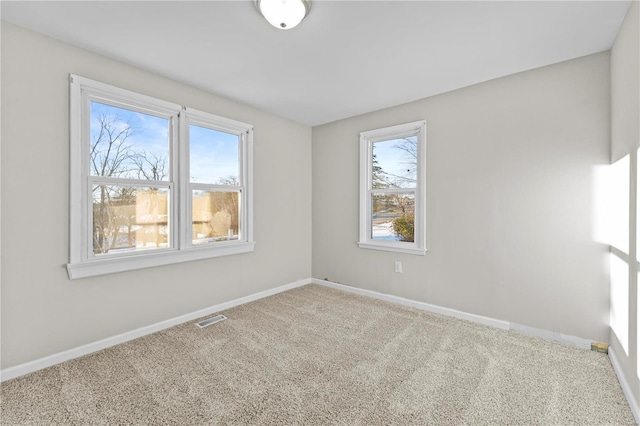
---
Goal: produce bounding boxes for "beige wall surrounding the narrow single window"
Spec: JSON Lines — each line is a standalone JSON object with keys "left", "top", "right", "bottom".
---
{"left": 312, "top": 52, "right": 610, "bottom": 341}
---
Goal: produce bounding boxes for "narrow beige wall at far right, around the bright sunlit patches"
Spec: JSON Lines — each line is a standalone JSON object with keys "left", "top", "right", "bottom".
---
{"left": 611, "top": 1, "right": 640, "bottom": 415}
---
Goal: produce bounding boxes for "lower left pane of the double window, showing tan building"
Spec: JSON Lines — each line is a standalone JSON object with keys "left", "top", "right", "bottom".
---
{"left": 92, "top": 185, "right": 169, "bottom": 255}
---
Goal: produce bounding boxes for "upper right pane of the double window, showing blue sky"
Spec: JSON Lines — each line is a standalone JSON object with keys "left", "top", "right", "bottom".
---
{"left": 189, "top": 125, "right": 240, "bottom": 185}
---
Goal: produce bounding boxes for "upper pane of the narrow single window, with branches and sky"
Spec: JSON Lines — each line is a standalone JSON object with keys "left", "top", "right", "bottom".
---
{"left": 371, "top": 136, "right": 418, "bottom": 189}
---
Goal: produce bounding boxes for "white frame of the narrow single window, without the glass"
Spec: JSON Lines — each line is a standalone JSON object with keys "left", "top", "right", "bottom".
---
{"left": 358, "top": 120, "right": 427, "bottom": 255}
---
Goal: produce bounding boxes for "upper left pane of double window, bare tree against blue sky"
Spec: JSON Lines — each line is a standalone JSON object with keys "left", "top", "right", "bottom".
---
{"left": 89, "top": 101, "right": 169, "bottom": 180}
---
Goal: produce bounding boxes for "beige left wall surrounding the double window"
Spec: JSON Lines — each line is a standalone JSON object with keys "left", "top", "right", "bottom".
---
{"left": 1, "top": 23, "right": 311, "bottom": 369}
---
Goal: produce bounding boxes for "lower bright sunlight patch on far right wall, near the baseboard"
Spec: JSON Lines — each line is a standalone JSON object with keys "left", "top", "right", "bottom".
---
{"left": 609, "top": 253, "right": 629, "bottom": 356}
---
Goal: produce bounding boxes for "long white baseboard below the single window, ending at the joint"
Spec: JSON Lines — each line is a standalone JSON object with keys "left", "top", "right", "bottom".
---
{"left": 311, "top": 278, "right": 510, "bottom": 330}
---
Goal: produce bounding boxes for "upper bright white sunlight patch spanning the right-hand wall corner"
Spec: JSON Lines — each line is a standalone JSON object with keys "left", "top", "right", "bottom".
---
{"left": 593, "top": 155, "right": 629, "bottom": 254}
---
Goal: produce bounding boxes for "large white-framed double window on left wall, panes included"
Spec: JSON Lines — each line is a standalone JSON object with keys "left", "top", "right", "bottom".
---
{"left": 67, "top": 75, "right": 254, "bottom": 278}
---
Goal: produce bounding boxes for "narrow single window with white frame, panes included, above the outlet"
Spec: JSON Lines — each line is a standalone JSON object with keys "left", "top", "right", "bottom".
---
{"left": 358, "top": 121, "right": 426, "bottom": 254}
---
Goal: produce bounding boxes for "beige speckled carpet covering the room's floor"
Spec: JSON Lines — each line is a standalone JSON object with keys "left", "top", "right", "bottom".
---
{"left": 1, "top": 285, "right": 635, "bottom": 425}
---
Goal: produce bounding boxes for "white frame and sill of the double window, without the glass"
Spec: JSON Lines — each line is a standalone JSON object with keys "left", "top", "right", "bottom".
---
{"left": 67, "top": 74, "right": 255, "bottom": 279}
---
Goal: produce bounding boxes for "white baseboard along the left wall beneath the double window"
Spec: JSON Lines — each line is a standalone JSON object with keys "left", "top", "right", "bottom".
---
{"left": 0, "top": 279, "right": 311, "bottom": 382}
